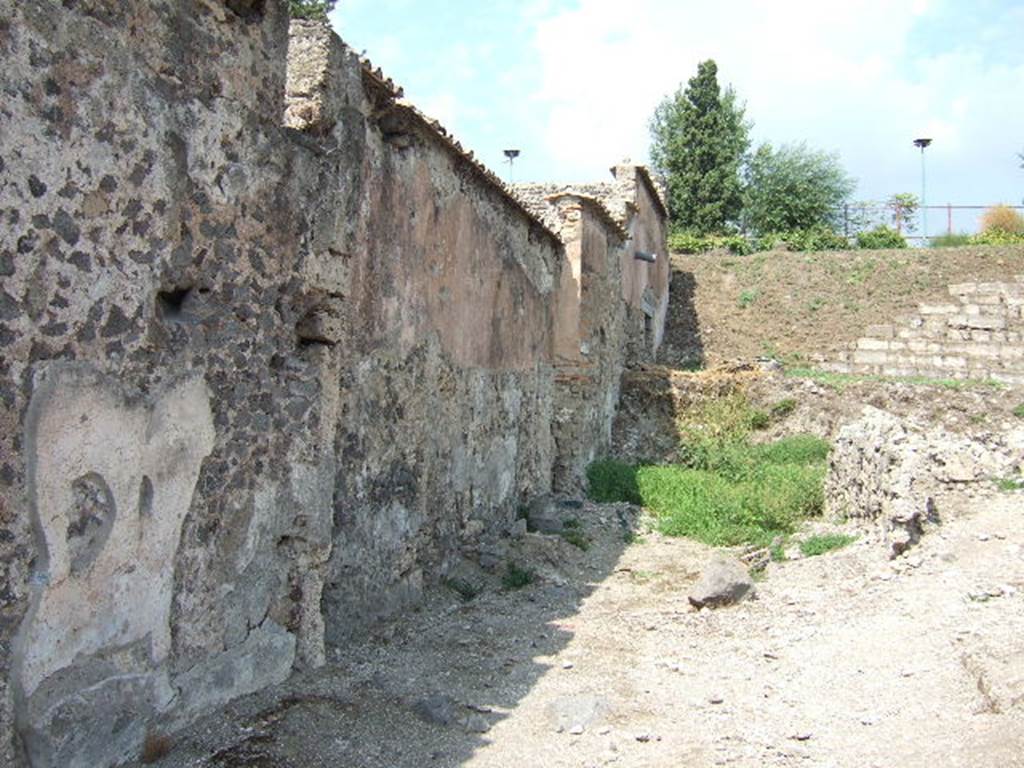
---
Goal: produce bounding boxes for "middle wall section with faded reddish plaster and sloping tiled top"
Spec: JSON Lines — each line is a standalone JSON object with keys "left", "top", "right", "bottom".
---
{"left": 289, "top": 23, "right": 563, "bottom": 642}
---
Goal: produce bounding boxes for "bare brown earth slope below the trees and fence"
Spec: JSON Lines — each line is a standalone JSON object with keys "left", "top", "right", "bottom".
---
{"left": 659, "top": 246, "right": 1024, "bottom": 368}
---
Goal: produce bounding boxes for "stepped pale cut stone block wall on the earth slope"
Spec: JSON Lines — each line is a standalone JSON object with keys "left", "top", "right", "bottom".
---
{"left": 820, "top": 275, "right": 1024, "bottom": 384}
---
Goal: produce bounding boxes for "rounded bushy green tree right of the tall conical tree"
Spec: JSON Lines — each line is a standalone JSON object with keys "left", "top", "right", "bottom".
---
{"left": 743, "top": 143, "right": 856, "bottom": 234}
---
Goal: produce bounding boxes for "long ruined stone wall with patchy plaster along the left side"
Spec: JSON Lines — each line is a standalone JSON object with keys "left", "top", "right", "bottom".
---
{"left": 0, "top": 0, "right": 668, "bottom": 768}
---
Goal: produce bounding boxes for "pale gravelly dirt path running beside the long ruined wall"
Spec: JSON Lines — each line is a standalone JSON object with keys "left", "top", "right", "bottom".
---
{"left": 146, "top": 494, "right": 1024, "bottom": 768}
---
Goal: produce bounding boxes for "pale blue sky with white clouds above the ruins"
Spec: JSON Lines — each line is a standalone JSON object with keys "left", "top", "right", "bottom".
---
{"left": 332, "top": 0, "right": 1024, "bottom": 229}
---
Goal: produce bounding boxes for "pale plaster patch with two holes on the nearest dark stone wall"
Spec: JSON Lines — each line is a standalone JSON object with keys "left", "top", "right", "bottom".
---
{"left": 18, "top": 366, "right": 215, "bottom": 696}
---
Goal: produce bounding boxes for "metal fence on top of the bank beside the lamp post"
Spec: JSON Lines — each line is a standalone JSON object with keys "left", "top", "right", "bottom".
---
{"left": 843, "top": 203, "right": 1024, "bottom": 242}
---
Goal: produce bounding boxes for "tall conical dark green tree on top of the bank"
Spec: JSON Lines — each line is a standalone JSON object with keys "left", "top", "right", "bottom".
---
{"left": 650, "top": 59, "right": 751, "bottom": 234}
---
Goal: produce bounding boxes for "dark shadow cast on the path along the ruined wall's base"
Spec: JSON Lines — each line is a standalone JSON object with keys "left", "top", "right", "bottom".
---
{"left": 128, "top": 504, "right": 637, "bottom": 768}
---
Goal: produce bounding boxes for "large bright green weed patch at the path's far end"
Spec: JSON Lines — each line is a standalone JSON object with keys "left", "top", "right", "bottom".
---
{"left": 588, "top": 395, "right": 829, "bottom": 546}
